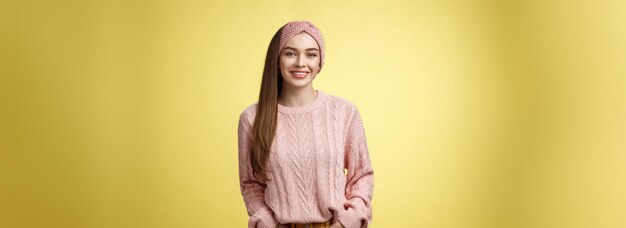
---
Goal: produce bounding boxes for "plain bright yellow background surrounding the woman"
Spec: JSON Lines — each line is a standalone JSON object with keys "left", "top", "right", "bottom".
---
{"left": 0, "top": 0, "right": 626, "bottom": 228}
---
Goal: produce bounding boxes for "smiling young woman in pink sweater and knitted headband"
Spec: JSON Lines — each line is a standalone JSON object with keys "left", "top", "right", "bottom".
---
{"left": 238, "top": 21, "right": 374, "bottom": 228}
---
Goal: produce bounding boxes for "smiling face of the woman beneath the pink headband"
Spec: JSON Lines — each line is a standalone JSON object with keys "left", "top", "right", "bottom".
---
{"left": 279, "top": 32, "right": 320, "bottom": 88}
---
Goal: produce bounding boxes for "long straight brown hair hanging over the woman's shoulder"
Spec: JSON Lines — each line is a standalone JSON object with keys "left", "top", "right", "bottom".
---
{"left": 250, "top": 27, "right": 283, "bottom": 180}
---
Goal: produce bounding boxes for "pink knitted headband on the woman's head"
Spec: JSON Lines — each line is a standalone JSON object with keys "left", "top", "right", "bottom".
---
{"left": 278, "top": 21, "right": 324, "bottom": 71}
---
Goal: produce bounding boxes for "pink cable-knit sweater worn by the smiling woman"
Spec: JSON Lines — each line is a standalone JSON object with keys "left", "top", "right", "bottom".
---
{"left": 238, "top": 90, "right": 374, "bottom": 228}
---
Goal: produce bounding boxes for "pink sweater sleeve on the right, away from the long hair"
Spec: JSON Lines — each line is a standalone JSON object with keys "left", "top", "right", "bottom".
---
{"left": 339, "top": 106, "right": 374, "bottom": 228}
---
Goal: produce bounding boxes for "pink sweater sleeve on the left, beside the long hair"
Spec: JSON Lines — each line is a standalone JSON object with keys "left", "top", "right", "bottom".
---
{"left": 238, "top": 111, "right": 279, "bottom": 228}
